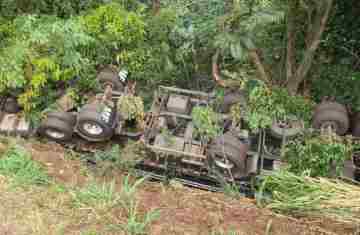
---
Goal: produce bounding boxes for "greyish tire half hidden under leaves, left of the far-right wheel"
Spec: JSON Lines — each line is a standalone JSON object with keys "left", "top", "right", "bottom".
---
{"left": 270, "top": 120, "right": 304, "bottom": 139}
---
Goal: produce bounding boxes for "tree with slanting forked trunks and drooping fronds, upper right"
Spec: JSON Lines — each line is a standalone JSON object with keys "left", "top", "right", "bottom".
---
{"left": 213, "top": 0, "right": 333, "bottom": 94}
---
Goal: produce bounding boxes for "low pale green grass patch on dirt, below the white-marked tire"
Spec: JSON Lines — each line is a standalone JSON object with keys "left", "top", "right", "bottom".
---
{"left": 71, "top": 181, "right": 119, "bottom": 208}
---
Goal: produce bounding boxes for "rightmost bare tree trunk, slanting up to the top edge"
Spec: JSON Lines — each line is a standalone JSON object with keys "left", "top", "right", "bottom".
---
{"left": 287, "top": 0, "right": 333, "bottom": 95}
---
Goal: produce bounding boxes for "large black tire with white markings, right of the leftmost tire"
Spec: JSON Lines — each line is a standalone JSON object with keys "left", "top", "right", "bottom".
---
{"left": 76, "top": 109, "right": 114, "bottom": 142}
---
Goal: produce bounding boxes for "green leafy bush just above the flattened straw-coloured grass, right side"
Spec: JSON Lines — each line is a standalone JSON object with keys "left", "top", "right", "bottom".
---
{"left": 285, "top": 134, "right": 352, "bottom": 177}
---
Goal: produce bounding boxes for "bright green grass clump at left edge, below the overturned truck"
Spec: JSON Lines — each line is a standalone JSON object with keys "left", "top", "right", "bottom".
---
{"left": 0, "top": 145, "right": 50, "bottom": 186}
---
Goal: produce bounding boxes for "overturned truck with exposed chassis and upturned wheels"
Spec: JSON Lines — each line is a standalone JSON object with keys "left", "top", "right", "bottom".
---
{"left": 0, "top": 68, "right": 360, "bottom": 190}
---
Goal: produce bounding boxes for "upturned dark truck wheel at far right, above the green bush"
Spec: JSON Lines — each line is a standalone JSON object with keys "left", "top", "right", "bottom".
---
{"left": 312, "top": 102, "right": 350, "bottom": 135}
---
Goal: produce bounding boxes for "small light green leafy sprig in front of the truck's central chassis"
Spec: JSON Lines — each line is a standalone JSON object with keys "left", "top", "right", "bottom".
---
{"left": 191, "top": 106, "right": 221, "bottom": 139}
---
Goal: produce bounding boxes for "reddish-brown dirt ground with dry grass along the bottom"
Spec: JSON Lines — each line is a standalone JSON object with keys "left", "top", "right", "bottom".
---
{"left": 0, "top": 140, "right": 357, "bottom": 235}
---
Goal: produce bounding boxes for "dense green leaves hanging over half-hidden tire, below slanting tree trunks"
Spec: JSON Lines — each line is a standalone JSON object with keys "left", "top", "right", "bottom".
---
{"left": 244, "top": 81, "right": 313, "bottom": 130}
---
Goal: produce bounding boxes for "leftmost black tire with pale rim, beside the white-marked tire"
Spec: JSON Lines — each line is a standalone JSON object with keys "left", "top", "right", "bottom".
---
{"left": 40, "top": 118, "right": 74, "bottom": 142}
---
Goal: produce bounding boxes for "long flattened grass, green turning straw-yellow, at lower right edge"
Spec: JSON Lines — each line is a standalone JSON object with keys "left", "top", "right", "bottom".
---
{"left": 258, "top": 170, "right": 360, "bottom": 224}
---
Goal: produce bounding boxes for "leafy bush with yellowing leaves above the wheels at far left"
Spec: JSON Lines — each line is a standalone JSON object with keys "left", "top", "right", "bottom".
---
{"left": 0, "top": 15, "right": 93, "bottom": 117}
